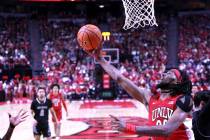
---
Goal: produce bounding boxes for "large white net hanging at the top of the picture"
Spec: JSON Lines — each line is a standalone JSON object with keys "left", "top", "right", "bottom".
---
{"left": 122, "top": 0, "right": 158, "bottom": 30}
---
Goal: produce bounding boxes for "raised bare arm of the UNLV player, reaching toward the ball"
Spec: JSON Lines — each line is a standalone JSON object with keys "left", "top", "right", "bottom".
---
{"left": 97, "top": 57, "right": 151, "bottom": 105}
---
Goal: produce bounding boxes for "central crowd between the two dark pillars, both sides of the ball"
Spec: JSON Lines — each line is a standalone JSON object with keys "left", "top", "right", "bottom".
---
{"left": 41, "top": 15, "right": 167, "bottom": 98}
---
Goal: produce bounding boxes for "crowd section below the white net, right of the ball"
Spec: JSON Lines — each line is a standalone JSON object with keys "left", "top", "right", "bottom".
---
{"left": 110, "top": 17, "right": 167, "bottom": 97}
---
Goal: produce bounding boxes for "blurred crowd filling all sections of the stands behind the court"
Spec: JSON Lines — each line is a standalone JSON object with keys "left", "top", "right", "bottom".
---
{"left": 0, "top": 11, "right": 210, "bottom": 100}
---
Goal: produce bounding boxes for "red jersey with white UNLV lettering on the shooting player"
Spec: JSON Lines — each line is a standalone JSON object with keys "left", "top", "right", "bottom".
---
{"left": 149, "top": 94, "right": 192, "bottom": 140}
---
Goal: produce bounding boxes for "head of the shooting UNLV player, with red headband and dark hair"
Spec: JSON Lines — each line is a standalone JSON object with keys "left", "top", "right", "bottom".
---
{"left": 157, "top": 68, "right": 192, "bottom": 95}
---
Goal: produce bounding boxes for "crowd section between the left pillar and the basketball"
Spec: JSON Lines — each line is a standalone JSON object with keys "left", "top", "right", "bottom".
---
{"left": 41, "top": 21, "right": 95, "bottom": 99}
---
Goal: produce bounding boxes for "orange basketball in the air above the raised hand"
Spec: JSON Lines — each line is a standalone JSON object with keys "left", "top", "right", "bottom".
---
{"left": 77, "top": 24, "right": 102, "bottom": 51}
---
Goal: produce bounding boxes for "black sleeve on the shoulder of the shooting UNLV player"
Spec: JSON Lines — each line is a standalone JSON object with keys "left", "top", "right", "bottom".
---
{"left": 176, "top": 95, "right": 193, "bottom": 112}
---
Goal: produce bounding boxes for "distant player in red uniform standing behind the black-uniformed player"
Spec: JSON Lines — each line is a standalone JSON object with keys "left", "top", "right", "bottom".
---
{"left": 48, "top": 84, "right": 68, "bottom": 139}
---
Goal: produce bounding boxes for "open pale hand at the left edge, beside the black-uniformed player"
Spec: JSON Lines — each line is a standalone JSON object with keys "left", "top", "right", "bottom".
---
{"left": 9, "top": 109, "right": 29, "bottom": 127}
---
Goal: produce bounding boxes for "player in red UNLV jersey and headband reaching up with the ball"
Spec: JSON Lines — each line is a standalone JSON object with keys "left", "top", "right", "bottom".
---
{"left": 87, "top": 50, "right": 193, "bottom": 140}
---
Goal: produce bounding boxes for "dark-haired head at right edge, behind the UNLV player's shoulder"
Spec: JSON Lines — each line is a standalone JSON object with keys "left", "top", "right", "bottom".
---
{"left": 194, "top": 90, "right": 210, "bottom": 108}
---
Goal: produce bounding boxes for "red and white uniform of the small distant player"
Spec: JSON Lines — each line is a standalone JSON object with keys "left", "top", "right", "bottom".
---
{"left": 49, "top": 93, "right": 67, "bottom": 122}
